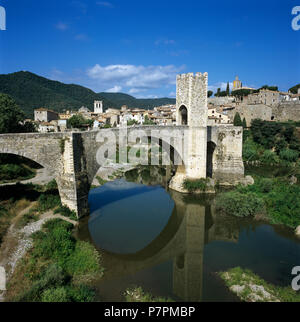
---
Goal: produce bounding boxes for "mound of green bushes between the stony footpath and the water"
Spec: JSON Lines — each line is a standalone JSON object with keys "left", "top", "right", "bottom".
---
{"left": 8, "top": 219, "right": 104, "bottom": 302}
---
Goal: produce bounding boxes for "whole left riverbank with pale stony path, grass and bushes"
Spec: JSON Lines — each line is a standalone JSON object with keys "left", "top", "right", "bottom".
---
{"left": 0, "top": 182, "right": 103, "bottom": 302}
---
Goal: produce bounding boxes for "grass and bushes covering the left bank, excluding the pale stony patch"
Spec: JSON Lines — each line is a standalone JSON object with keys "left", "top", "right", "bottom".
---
{"left": 0, "top": 180, "right": 104, "bottom": 302}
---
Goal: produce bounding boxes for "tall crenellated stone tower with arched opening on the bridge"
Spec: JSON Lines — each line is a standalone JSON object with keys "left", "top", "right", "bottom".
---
{"left": 176, "top": 73, "right": 208, "bottom": 179}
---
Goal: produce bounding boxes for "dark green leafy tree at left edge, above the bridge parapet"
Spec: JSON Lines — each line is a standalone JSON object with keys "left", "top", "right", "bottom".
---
{"left": 0, "top": 94, "right": 25, "bottom": 133}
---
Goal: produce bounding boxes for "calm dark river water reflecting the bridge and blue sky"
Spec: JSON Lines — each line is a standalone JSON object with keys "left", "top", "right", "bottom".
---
{"left": 79, "top": 169, "right": 300, "bottom": 301}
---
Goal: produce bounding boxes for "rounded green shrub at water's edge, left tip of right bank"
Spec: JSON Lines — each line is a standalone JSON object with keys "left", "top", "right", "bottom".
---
{"left": 216, "top": 191, "right": 264, "bottom": 217}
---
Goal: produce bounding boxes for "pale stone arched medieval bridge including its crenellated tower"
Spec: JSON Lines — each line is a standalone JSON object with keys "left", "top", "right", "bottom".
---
{"left": 0, "top": 73, "right": 244, "bottom": 217}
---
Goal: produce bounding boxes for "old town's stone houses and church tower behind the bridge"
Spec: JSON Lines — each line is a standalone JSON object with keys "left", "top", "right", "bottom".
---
{"left": 32, "top": 76, "right": 300, "bottom": 133}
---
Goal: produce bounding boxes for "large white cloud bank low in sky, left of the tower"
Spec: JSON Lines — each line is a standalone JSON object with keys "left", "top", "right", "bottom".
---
{"left": 87, "top": 64, "right": 183, "bottom": 92}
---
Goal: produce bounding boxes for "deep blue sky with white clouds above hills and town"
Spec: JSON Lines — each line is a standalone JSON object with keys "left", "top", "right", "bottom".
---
{"left": 0, "top": 0, "right": 300, "bottom": 97}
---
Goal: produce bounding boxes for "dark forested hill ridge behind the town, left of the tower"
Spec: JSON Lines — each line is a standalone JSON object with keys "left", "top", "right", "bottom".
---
{"left": 0, "top": 72, "right": 175, "bottom": 117}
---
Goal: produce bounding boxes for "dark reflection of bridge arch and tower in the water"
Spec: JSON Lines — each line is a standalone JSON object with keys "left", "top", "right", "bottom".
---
{"left": 80, "top": 184, "right": 239, "bottom": 301}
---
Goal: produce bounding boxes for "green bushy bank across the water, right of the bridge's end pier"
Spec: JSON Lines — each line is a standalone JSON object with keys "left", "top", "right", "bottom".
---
{"left": 216, "top": 177, "right": 300, "bottom": 229}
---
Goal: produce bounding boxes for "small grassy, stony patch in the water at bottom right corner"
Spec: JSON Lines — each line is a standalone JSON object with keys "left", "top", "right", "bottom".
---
{"left": 219, "top": 267, "right": 300, "bottom": 302}
